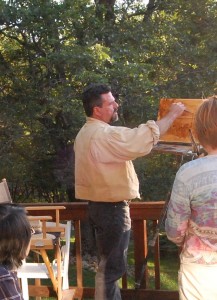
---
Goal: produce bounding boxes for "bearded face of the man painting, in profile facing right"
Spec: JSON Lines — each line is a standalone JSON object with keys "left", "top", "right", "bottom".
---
{"left": 94, "top": 92, "right": 118, "bottom": 123}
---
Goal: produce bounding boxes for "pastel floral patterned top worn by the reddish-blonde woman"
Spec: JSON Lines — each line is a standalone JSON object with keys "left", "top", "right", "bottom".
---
{"left": 165, "top": 155, "right": 217, "bottom": 265}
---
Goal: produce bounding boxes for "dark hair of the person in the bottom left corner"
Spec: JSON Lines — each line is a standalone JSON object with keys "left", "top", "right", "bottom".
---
{"left": 0, "top": 204, "right": 31, "bottom": 270}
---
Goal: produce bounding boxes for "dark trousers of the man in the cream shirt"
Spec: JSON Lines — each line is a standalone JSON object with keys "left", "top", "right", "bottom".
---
{"left": 88, "top": 201, "right": 131, "bottom": 300}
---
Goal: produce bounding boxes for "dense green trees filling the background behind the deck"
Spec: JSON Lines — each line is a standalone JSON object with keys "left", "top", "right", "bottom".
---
{"left": 0, "top": 0, "right": 217, "bottom": 202}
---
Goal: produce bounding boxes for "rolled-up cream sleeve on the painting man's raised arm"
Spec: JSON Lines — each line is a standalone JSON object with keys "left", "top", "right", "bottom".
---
{"left": 91, "top": 120, "right": 160, "bottom": 163}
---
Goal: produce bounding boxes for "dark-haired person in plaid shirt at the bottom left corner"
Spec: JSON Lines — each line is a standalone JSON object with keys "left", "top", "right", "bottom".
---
{"left": 0, "top": 204, "right": 31, "bottom": 300}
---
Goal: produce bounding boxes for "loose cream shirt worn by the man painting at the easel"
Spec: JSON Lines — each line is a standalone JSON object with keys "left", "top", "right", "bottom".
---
{"left": 74, "top": 118, "right": 160, "bottom": 202}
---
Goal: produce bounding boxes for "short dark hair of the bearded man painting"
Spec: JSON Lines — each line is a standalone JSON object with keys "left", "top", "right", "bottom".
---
{"left": 82, "top": 83, "right": 111, "bottom": 117}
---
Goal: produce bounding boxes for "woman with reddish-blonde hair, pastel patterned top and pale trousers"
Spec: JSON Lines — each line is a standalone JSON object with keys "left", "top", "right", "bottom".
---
{"left": 165, "top": 96, "right": 217, "bottom": 300}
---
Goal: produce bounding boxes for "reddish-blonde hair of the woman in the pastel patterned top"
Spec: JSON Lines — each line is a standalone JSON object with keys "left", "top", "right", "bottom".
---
{"left": 194, "top": 95, "right": 217, "bottom": 149}
